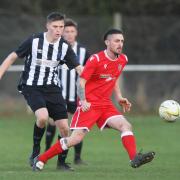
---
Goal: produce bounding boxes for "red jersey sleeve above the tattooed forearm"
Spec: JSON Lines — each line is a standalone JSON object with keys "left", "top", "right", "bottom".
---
{"left": 80, "top": 55, "right": 98, "bottom": 80}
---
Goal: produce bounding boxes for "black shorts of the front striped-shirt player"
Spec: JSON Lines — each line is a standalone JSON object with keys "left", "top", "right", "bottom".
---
{"left": 22, "top": 85, "right": 68, "bottom": 121}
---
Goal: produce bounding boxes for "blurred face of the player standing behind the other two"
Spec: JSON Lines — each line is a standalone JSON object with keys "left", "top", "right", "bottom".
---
{"left": 63, "top": 26, "right": 77, "bottom": 44}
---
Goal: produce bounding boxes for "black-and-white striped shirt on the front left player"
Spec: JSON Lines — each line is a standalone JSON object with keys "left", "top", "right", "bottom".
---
{"left": 15, "top": 33, "right": 79, "bottom": 86}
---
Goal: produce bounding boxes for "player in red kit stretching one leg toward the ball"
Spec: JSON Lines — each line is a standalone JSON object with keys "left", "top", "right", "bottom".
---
{"left": 33, "top": 29, "right": 155, "bottom": 170}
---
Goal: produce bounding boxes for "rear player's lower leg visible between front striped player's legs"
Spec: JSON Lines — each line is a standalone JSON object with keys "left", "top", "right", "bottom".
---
{"left": 45, "top": 119, "right": 56, "bottom": 150}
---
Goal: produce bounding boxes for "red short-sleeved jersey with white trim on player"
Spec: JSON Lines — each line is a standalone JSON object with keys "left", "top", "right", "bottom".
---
{"left": 81, "top": 50, "right": 128, "bottom": 106}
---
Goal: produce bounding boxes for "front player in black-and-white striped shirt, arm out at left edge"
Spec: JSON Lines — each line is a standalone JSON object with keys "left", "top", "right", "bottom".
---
{"left": 0, "top": 12, "right": 82, "bottom": 170}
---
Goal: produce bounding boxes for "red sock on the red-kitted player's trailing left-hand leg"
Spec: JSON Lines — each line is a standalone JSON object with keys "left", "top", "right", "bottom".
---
{"left": 38, "top": 140, "right": 63, "bottom": 163}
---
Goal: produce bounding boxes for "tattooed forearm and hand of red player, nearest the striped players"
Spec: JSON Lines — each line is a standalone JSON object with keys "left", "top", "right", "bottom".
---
{"left": 77, "top": 77, "right": 91, "bottom": 111}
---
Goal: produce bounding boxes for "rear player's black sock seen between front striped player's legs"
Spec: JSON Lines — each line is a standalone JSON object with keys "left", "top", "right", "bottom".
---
{"left": 46, "top": 124, "right": 56, "bottom": 150}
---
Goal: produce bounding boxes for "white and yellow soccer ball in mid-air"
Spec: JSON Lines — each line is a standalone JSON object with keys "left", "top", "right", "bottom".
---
{"left": 159, "top": 100, "right": 180, "bottom": 122}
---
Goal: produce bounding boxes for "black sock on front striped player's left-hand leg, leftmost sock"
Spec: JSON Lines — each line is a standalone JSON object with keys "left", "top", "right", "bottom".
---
{"left": 33, "top": 123, "right": 45, "bottom": 155}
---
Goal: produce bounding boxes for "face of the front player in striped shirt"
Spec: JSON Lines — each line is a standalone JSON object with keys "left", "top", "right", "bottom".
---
{"left": 46, "top": 20, "right": 64, "bottom": 41}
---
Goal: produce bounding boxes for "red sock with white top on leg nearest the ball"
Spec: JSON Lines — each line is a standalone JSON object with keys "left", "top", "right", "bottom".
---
{"left": 121, "top": 131, "right": 137, "bottom": 160}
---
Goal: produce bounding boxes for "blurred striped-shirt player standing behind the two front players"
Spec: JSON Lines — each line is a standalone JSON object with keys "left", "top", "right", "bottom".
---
{"left": 46, "top": 19, "right": 90, "bottom": 170}
